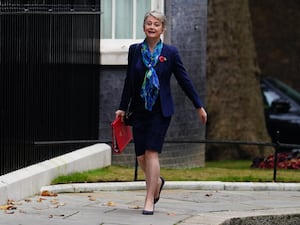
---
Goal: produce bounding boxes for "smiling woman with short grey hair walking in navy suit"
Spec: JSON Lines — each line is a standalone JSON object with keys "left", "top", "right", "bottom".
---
{"left": 116, "top": 11, "right": 207, "bottom": 215}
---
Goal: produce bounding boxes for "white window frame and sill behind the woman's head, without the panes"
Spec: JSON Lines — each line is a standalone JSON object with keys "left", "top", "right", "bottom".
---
{"left": 99, "top": 0, "right": 164, "bottom": 65}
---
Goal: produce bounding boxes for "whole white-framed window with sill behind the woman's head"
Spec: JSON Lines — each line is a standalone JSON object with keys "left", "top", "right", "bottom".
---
{"left": 100, "top": 0, "right": 164, "bottom": 65}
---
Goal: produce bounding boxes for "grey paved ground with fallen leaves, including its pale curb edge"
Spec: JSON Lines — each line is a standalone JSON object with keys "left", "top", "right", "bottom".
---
{"left": 0, "top": 181, "right": 300, "bottom": 225}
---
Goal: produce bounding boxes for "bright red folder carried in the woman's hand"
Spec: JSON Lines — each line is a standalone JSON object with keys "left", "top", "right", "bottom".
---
{"left": 111, "top": 117, "right": 132, "bottom": 153}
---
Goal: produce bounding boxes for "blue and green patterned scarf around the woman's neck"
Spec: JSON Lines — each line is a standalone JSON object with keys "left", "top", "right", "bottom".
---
{"left": 140, "top": 40, "right": 163, "bottom": 111}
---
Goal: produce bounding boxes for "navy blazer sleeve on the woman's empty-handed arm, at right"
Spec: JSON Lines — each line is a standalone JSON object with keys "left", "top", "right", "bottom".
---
{"left": 172, "top": 46, "right": 203, "bottom": 108}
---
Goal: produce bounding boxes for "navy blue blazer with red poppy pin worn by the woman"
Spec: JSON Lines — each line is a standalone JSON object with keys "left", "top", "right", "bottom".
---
{"left": 119, "top": 44, "right": 203, "bottom": 117}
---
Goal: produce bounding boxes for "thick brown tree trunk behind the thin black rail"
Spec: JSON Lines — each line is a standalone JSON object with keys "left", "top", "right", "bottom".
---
{"left": 206, "top": 0, "right": 271, "bottom": 160}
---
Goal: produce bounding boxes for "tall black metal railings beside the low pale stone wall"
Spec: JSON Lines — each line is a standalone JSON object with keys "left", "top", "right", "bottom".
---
{"left": 0, "top": 0, "right": 100, "bottom": 175}
